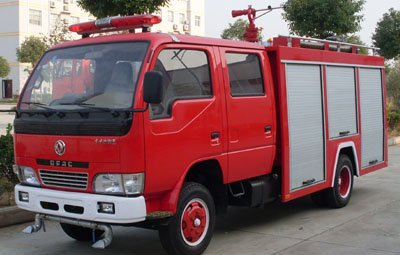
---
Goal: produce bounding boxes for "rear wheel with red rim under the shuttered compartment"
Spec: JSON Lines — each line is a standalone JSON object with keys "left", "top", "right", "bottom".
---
{"left": 326, "top": 155, "right": 354, "bottom": 208}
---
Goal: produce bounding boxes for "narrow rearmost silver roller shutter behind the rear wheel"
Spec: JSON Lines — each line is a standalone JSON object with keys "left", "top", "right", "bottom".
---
{"left": 360, "top": 68, "right": 384, "bottom": 168}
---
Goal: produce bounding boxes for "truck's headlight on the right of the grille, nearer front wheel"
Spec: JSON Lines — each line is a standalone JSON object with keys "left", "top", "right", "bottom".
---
{"left": 93, "top": 173, "right": 144, "bottom": 195}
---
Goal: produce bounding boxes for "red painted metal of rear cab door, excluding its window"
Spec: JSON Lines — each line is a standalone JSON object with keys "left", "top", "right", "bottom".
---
{"left": 217, "top": 48, "right": 275, "bottom": 182}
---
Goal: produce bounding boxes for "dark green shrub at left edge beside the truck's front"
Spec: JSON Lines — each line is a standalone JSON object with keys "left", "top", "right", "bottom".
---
{"left": 0, "top": 124, "right": 19, "bottom": 192}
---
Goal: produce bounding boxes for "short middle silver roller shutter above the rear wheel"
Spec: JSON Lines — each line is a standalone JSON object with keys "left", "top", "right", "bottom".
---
{"left": 326, "top": 66, "right": 357, "bottom": 138}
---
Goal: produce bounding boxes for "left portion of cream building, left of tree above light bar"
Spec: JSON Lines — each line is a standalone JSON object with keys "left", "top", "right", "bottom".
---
{"left": 0, "top": 0, "right": 94, "bottom": 97}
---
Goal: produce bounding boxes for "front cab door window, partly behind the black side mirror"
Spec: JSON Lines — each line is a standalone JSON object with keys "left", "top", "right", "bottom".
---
{"left": 150, "top": 49, "right": 212, "bottom": 119}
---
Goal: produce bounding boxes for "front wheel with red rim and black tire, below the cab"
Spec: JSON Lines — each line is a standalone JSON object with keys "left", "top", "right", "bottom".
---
{"left": 158, "top": 182, "right": 216, "bottom": 255}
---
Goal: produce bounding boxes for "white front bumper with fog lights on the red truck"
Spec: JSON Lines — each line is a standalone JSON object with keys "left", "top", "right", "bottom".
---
{"left": 15, "top": 184, "right": 146, "bottom": 224}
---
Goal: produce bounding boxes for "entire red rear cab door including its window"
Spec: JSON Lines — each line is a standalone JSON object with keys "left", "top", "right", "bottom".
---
{"left": 220, "top": 48, "right": 276, "bottom": 182}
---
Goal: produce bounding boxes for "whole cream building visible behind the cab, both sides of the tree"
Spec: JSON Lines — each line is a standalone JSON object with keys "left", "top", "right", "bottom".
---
{"left": 0, "top": 0, "right": 205, "bottom": 98}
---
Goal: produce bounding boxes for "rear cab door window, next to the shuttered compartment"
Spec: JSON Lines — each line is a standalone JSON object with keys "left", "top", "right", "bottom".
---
{"left": 225, "top": 53, "right": 264, "bottom": 97}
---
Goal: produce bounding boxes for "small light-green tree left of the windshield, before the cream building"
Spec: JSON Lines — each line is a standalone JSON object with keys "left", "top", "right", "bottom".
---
{"left": 17, "top": 36, "right": 48, "bottom": 67}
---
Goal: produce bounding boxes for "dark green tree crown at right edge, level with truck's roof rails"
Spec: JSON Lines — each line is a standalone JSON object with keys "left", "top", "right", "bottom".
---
{"left": 372, "top": 8, "right": 400, "bottom": 59}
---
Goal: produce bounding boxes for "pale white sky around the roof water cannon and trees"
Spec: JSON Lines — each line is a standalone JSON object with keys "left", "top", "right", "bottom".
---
{"left": 205, "top": 0, "right": 400, "bottom": 45}
